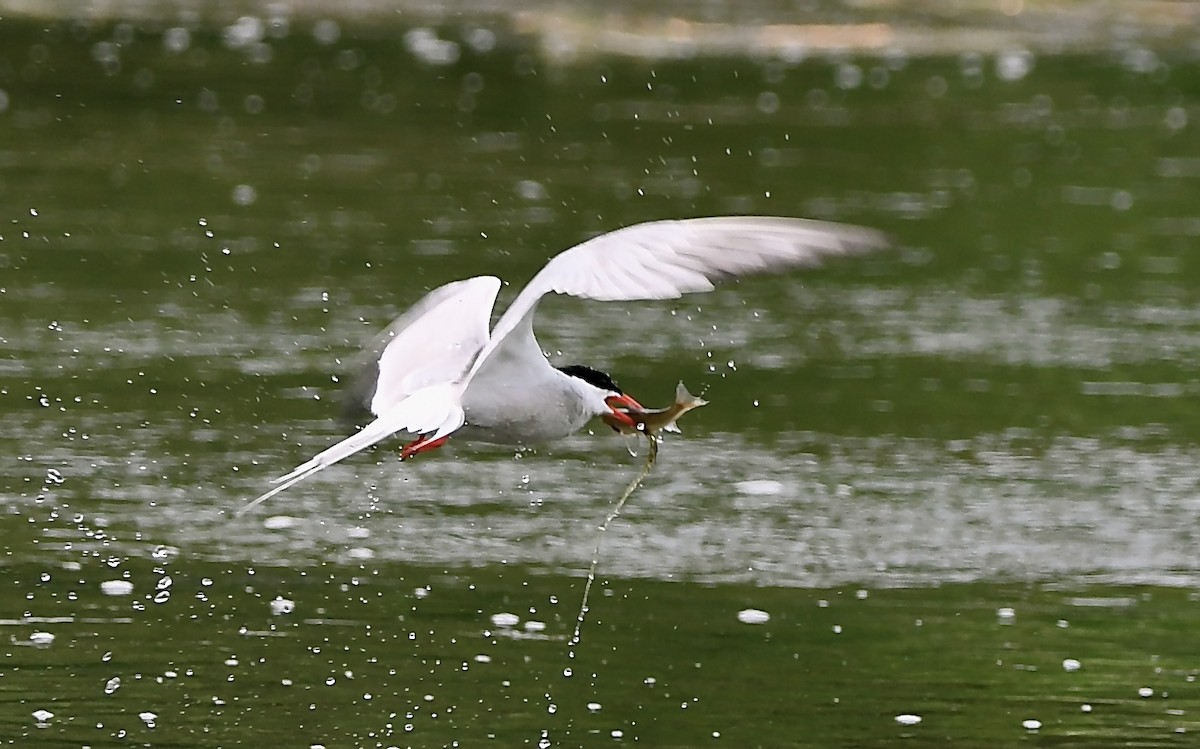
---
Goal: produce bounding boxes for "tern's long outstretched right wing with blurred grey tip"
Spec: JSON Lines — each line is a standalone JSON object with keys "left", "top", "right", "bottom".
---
{"left": 468, "top": 216, "right": 888, "bottom": 378}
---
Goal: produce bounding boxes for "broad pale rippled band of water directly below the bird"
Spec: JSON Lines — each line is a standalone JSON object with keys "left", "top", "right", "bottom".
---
{"left": 39, "top": 422, "right": 1200, "bottom": 590}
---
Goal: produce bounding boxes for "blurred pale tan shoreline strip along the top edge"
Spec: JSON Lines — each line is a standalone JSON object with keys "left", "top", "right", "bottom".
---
{"left": 0, "top": 0, "right": 1200, "bottom": 61}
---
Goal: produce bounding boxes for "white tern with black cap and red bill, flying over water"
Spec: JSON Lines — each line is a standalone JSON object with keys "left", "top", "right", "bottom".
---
{"left": 241, "top": 216, "right": 888, "bottom": 513}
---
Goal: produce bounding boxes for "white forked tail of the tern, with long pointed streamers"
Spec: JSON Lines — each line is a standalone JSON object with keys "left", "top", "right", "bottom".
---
{"left": 238, "top": 383, "right": 464, "bottom": 515}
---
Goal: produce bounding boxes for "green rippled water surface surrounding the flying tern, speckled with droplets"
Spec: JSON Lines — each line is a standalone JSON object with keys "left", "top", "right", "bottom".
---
{"left": 0, "top": 7, "right": 1200, "bottom": 748}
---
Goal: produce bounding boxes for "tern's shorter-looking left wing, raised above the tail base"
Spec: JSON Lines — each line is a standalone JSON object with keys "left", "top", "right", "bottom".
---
{"left": 370, "top": 276, "right": 500, "bottom": 417}
